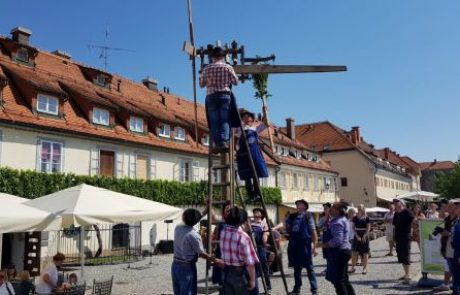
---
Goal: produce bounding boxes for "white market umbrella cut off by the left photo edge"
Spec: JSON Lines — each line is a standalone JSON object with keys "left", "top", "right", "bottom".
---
{"left": 0, "top": 196, "right": 61, "bottom": 233}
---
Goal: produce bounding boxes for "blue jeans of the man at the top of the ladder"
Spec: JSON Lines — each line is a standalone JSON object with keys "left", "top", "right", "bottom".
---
{"left": 206, "top": 93, "right": 230, "bottom": 146}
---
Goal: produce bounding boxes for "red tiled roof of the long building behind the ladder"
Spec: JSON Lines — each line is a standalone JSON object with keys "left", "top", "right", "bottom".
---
{"left": 0, "top": 37, "right": 333, "bottom": 172}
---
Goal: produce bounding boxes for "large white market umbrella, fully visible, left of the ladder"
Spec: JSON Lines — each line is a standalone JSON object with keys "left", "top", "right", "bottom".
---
{"left": 24, "top": 184, "right": 182, "bottom": 228}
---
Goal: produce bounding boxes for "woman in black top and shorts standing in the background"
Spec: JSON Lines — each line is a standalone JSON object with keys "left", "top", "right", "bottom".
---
{"left": 350, "top": 204, "right": 371, "bottom": 275}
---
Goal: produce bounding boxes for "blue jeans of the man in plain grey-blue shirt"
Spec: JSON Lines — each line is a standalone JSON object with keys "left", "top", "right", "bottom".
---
{"left": 171, "top": 261, "right": 197, "bottom": 295}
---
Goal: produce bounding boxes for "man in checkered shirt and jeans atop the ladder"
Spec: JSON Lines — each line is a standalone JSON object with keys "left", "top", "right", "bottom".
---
{"left": 200, "top": 46, "right": 238, "bottom": 152}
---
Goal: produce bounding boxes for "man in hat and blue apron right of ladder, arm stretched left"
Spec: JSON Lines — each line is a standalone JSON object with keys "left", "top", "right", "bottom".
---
{"left": 275, "top": 200, "right": 318, "bottom": 295}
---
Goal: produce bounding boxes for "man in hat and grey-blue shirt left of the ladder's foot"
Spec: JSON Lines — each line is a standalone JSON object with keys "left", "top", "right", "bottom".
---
{"left": 171, "top": 208, "right": 223, "bottom": 295}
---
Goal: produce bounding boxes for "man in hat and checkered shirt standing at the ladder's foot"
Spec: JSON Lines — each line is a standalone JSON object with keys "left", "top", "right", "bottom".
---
{"left": 219, "top": 207, "right": 259, "bottom": 295}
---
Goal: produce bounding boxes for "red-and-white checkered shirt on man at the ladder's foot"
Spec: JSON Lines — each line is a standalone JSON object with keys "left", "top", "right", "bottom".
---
{"left": 220, "top": 225, "right": 259, "bottom": 266}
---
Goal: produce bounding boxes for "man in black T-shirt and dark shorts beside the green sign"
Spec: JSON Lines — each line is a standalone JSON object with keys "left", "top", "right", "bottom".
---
{"left": 393, "top": 199, "right": 414, "bottom": 284}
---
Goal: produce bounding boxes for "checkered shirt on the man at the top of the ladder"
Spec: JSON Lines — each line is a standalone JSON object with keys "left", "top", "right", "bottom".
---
{"left": 200, "top": 62, "right": 238, "bottom": 95}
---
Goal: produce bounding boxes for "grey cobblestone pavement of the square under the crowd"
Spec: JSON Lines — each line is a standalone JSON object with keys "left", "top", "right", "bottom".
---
{"left": 85, "top": 238, "right": 446, "bottom": 295}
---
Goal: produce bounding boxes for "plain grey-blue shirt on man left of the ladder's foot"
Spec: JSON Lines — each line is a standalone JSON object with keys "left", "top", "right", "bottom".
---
{"left": 174, "top": 224, "right": 204, "bottom": 262}
